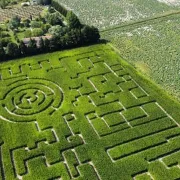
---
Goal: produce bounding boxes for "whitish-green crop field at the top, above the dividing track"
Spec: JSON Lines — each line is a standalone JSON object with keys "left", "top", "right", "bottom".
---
{"left": 56, "top": 0, "right": 178, "bottom": 29}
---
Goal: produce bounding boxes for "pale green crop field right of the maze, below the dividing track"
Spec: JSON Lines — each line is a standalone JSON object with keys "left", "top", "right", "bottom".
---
{"left": 102, "top": 15, "right": 180, "bottom": 99}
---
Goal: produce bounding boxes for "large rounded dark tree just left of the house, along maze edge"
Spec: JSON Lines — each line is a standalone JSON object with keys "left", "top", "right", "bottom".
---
{"left": 6, "top": 42, "right": 20, "bottom": 58}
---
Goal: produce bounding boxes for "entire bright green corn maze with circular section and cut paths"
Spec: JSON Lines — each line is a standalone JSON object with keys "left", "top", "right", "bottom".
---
{"left": 0, "top": 45, "right": 180, "bottom": 180}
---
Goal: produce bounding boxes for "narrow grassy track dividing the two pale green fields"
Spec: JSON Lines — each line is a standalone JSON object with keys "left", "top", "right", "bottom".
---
{"left": 100, "top": 11, "right": 180, "bottom": 33}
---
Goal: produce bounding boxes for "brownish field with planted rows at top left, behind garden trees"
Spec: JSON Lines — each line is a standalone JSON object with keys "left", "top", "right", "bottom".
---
{"left": 0, "top": 6, "right": 44, "bottom": 22}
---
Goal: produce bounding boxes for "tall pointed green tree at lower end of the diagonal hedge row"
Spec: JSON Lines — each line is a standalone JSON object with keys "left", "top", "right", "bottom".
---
{"left": 66, "top": 11, "right": 82, "bottom": 29}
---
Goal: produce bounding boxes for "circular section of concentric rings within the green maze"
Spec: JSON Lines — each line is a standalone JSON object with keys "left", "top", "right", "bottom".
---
{"left": 2, "top": 79, "right": 63, "bottom": 122}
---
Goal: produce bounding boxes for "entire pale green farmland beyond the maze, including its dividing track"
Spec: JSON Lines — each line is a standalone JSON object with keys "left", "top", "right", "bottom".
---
{"left": 57, "top": 0, "right": 180, "bottom": 100}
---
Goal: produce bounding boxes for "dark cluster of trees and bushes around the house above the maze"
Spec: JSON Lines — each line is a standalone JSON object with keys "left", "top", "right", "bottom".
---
{"left": 0, "top": 1, "right": 100, "bottom": 60}
